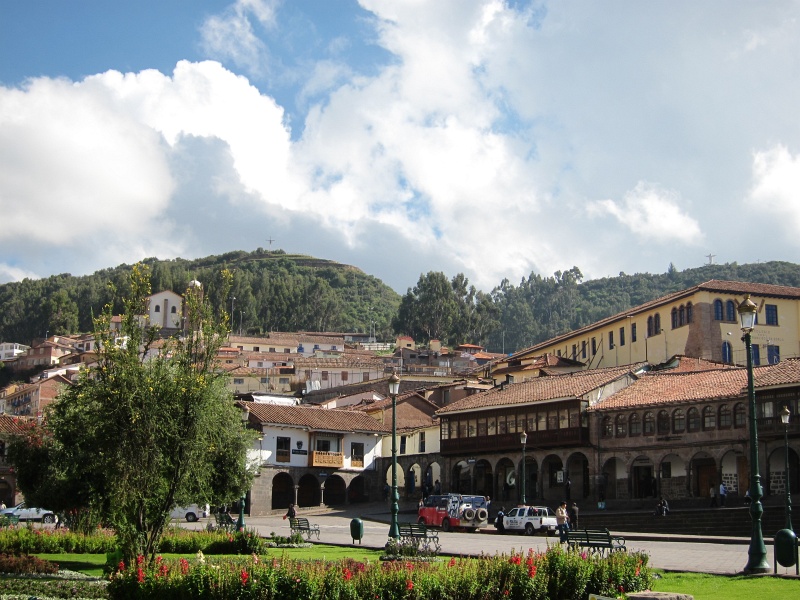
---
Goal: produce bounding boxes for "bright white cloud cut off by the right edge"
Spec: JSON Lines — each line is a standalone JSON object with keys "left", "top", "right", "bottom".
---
{"left": 744, "top": 145, "right": 800, "bottom": 237}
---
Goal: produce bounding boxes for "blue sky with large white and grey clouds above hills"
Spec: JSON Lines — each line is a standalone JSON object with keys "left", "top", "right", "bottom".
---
{"left": 0, "top": 0, "right": 800, "bottom": 293}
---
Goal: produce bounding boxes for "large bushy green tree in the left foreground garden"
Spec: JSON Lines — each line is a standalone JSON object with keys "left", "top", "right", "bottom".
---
{"left": 10, "top": 265, "right": 253, "bottom": 561}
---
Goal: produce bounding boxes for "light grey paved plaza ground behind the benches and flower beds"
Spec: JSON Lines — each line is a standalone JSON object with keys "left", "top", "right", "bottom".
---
{"left": 183, "top": 505, "right": 795, "bottom": 575}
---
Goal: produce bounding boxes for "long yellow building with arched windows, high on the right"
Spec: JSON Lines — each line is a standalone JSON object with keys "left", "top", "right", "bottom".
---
{"left": 500, "top": 280, "right": 800, "bottom": 372}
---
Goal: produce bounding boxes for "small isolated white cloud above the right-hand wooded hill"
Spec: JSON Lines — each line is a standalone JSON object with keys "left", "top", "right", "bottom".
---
{"left": 588, "top": 182, "right": 703, "bottom": 245}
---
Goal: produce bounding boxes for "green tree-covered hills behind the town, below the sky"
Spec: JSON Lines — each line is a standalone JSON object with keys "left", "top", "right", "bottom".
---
{"left": 0, "top": 248, "right": 800, "bottom": 353}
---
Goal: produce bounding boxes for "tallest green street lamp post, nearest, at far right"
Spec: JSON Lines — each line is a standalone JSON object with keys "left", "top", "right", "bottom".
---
{"left": 737, "top": 294, "right": 770, "bottom": 573}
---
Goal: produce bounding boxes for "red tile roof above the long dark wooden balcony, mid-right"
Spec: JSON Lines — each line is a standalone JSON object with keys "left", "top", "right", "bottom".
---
{"left": 437, "top": 366, "right": 631, "bottom": 415}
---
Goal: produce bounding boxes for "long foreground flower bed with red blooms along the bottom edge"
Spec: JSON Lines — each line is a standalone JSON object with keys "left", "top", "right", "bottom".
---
{"left": 108, "top": 546, "right": 652, "bottom": 600}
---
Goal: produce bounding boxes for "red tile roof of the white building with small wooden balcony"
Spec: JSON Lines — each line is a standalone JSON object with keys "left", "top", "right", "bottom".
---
{"left": 241, "top": 402, "right": 391, "bottom": 433}
